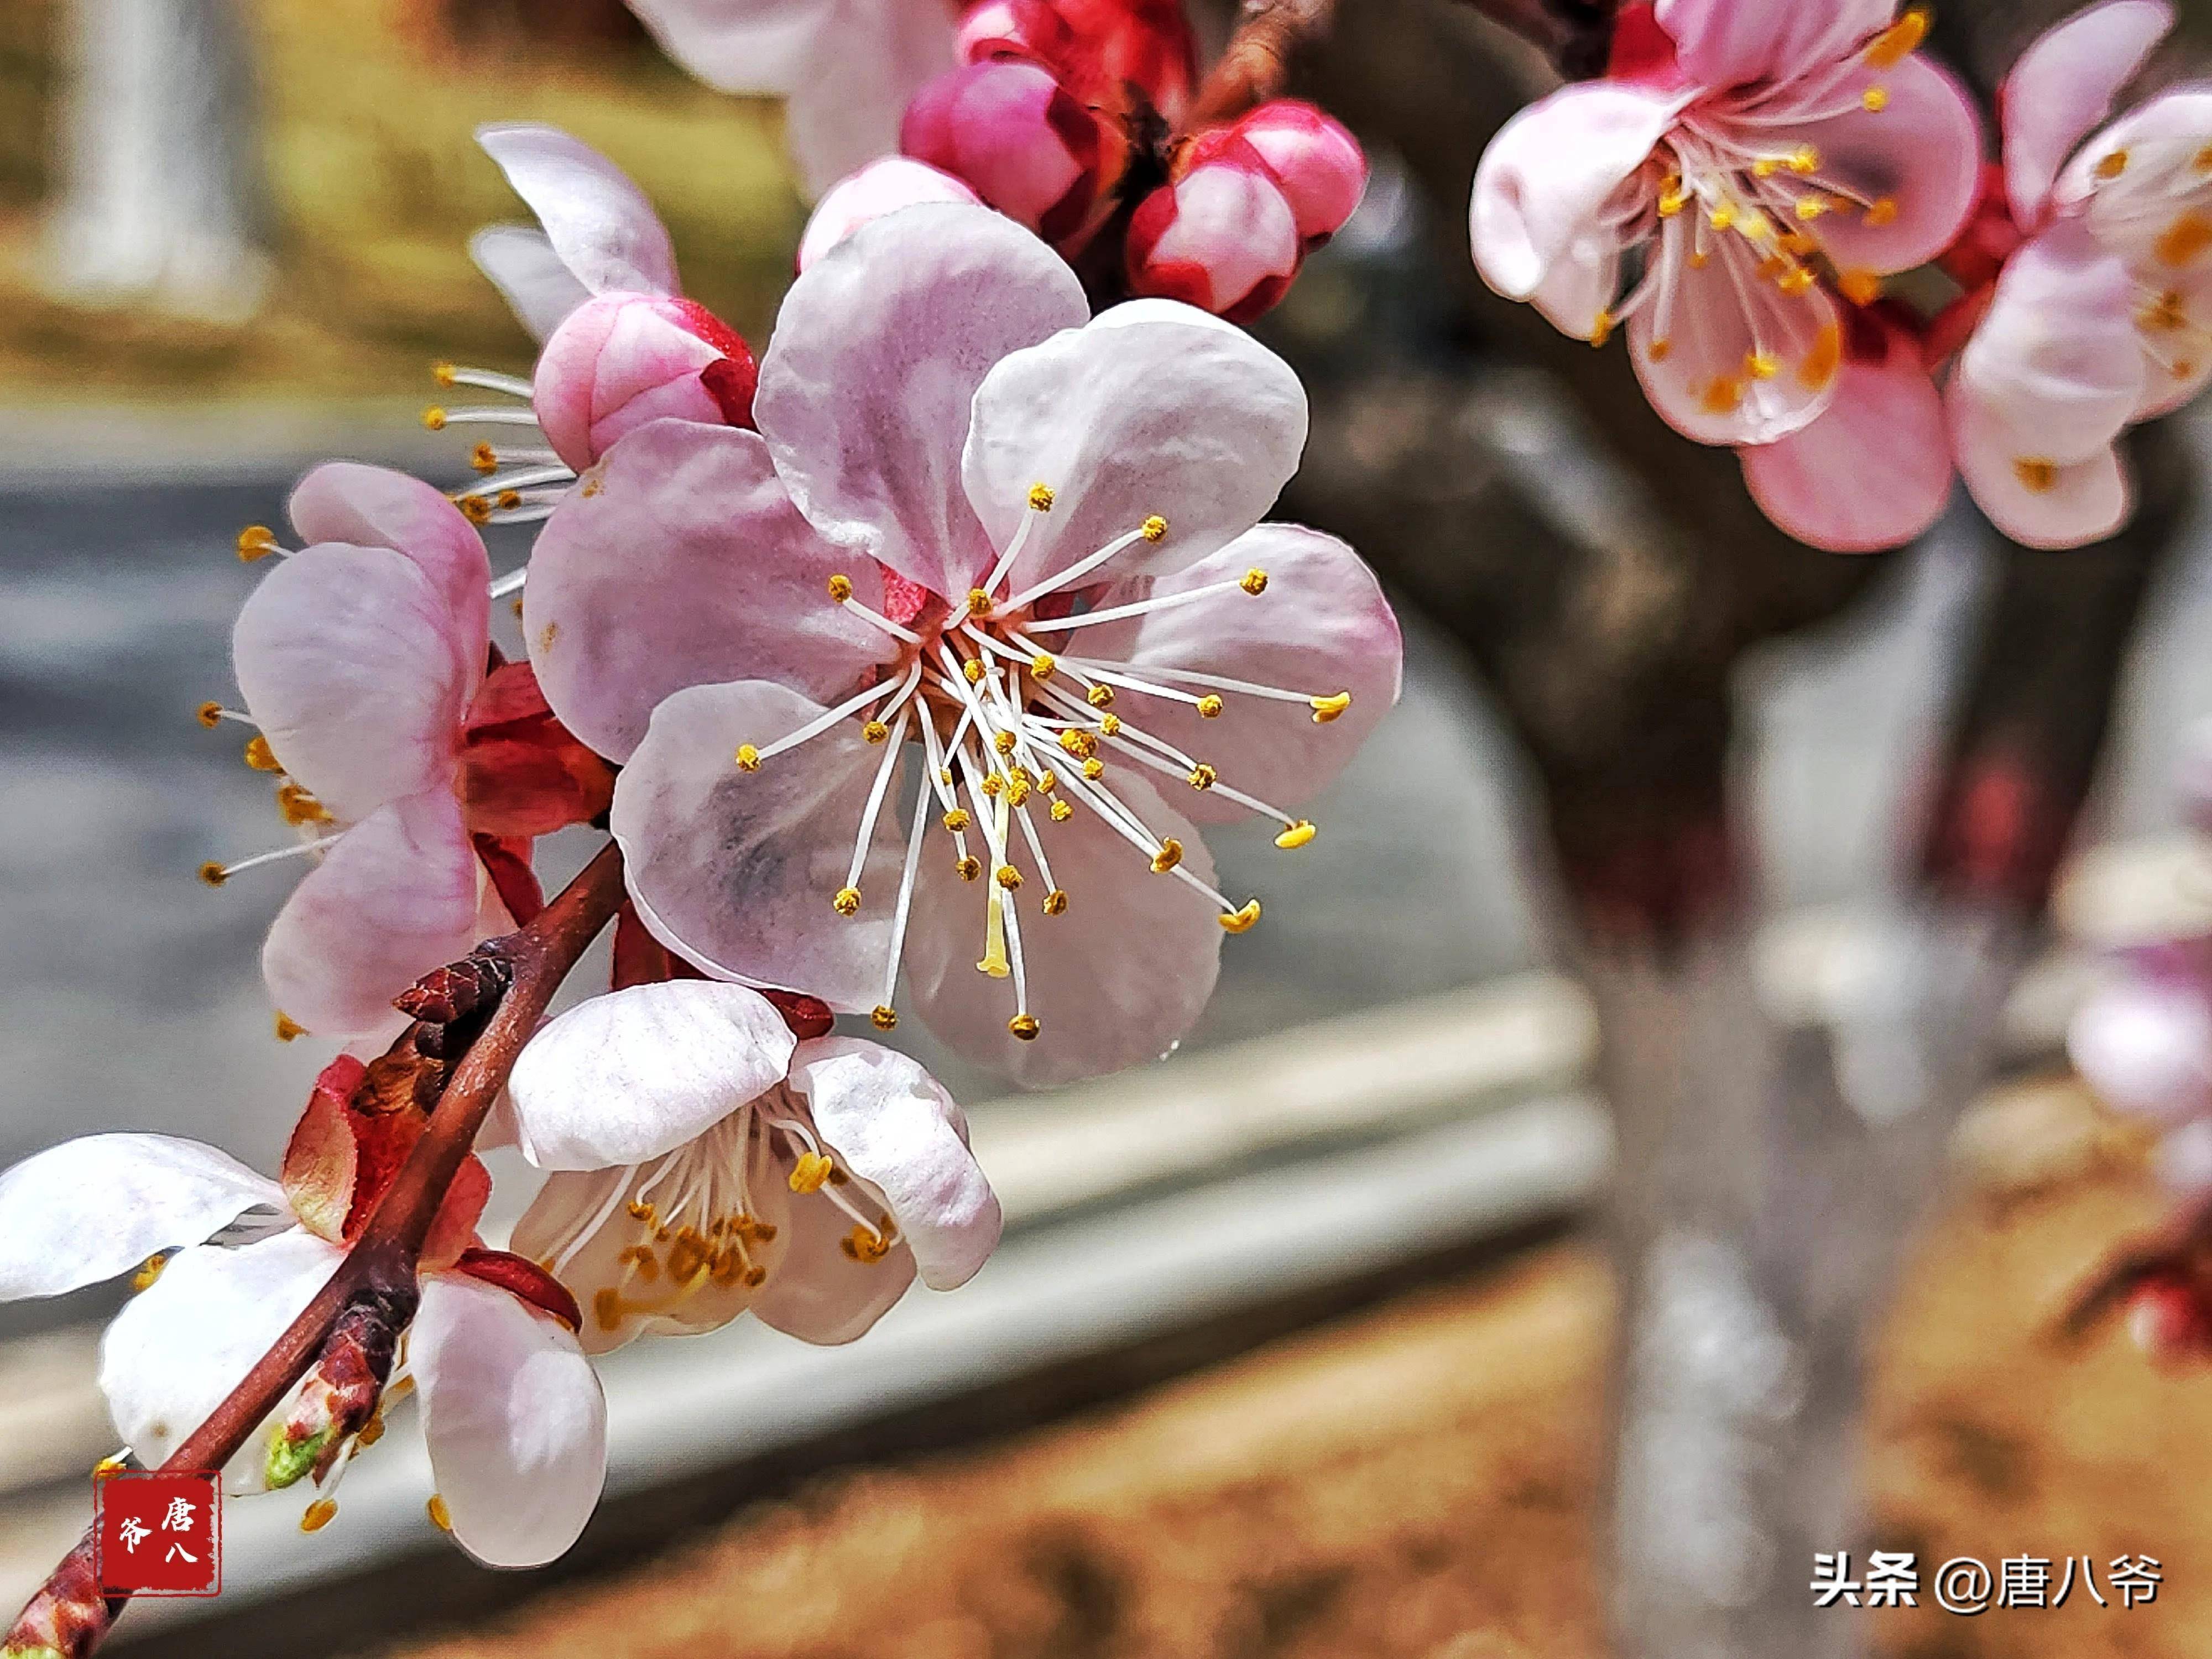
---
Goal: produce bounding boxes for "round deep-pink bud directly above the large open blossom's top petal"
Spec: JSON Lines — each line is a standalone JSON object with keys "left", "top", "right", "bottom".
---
{"left": 898, "top": 58, "right": 1104, "bottom": 241}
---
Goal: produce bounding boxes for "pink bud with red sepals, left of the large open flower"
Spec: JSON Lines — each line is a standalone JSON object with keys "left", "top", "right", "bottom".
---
{"left": 531, "top": 292, "right": 757, "bottom": 471}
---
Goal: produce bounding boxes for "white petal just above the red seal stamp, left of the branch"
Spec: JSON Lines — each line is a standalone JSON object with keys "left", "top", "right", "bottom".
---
{"left": 100, "top": 1228, "right": 343, "bottom": 1495}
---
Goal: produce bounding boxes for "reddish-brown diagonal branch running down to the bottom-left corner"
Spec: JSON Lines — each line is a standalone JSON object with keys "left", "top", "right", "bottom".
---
{"left": 0, "top": 843, "right": 622, "bottom": 1659}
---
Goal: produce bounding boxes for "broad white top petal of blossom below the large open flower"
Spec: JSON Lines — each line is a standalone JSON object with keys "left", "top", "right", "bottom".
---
{"left": 507, "top": 982, "right": 796, "bottom": 1170}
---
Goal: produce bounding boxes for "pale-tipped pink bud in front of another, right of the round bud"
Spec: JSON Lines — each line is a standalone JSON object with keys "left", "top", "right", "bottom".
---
{"left": 1128, "top": 131, "right": 1303, "bottom": 323}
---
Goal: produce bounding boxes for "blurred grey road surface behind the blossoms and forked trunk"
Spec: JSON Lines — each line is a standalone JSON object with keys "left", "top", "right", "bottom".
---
{"left": 0, "top": 407, "right": 2212, "bottom": 1274}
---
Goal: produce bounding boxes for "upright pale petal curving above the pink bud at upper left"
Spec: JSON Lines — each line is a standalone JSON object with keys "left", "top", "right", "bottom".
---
{"left": 476, "top": 124, "right": 684, "bottom": 294}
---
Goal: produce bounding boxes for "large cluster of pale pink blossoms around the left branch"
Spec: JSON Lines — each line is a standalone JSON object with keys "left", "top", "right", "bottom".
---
{"left": 0, "top": 35, "right": 1400, "bottom": 1566}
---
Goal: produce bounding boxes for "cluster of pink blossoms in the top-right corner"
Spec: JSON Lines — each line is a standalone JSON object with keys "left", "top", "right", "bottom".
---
{"left": 1471, "top": 0, "right": 2212, "bottom": 551}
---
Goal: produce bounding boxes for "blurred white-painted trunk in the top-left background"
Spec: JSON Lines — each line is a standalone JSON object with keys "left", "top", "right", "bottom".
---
{"left": 42, "top": 0, "right": 268, "bottom": 323}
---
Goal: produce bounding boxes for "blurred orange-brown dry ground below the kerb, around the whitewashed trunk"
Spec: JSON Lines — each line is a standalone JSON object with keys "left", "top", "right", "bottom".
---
{"left": 389, "top": 1088, "right": 2212, "bottom": 1659}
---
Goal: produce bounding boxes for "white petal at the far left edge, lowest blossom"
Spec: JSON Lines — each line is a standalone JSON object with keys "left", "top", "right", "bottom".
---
{"left": 0, "top": 1135, "right": 285, "bottom": 1301}
